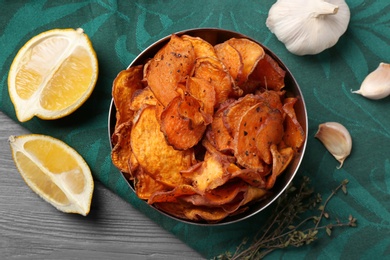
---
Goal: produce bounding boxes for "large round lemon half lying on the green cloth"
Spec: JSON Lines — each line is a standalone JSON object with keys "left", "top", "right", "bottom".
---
{"left": 8, "top": 28, "right": 98, "bottom": 122}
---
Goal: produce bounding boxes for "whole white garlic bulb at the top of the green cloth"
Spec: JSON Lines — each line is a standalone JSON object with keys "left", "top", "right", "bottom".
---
{"left": 266, "top": 0, "right": 350, "bottom": 55}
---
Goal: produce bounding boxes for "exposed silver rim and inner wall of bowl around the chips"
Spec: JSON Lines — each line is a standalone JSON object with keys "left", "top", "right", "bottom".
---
{"left": 108, "top": 27, "right": 308, "bottom": 226}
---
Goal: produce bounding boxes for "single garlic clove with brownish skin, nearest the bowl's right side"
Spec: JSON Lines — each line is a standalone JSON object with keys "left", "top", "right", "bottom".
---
{"left": 315, "top": 122, "right": 352, "bottom": 169}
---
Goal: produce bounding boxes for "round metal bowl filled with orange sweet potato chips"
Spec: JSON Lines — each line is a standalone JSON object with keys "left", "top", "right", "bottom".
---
{"left": 109, "top": 28, "right": 307, "bottom": 225}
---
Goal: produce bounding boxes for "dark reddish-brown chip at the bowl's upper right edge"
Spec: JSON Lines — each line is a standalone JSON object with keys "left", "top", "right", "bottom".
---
{"left": 248, "top": 54, "right": 286, "bottom": 91}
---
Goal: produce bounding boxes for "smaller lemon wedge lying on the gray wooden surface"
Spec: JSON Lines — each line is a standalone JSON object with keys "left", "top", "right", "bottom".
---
{"left": 9, "top": 134, "right": 94, "bottom": 216}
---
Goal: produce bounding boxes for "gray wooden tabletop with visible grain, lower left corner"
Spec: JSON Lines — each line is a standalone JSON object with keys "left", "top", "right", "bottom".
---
{"left": 0, "top": 112, "right": 201, "bottom": 259}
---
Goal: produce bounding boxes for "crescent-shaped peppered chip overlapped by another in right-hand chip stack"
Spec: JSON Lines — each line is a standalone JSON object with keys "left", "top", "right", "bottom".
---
{"left": 234, "top": 102, "right": 271, "bottom": 172}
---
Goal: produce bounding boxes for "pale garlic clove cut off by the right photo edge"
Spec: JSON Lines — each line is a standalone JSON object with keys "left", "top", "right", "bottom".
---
{"left": 352, "top": 62, "right": 390, "bottom": 99}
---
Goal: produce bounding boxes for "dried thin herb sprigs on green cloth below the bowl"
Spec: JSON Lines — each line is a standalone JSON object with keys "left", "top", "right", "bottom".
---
{"left": 215, "top": 177, "right": 357, "bottom": 260}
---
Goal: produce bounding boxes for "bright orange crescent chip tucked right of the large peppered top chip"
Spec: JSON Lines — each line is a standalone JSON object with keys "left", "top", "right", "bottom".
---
{"left": 192, "top": 57, "right": 238, "bottom": 106}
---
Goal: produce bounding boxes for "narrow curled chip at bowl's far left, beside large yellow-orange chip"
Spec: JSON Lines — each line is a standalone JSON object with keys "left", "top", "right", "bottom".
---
{"left": 111, "top": 121, "right": 138, "bottom": 175}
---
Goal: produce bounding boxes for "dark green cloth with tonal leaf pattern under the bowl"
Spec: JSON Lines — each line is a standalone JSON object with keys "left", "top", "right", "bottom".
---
{"left": 0, "top": 0, "right": 390, "bottom": 259}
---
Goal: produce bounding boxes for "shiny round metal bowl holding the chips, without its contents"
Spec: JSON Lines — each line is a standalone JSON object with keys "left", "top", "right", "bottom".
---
{"left": 108, "top": 28, "right": 308, "bottom": 226}
